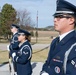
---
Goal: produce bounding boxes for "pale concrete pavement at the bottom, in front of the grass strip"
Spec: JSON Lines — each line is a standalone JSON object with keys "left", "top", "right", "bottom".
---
{"left": 0, "top": 62, "right": 43, "bottom": 75}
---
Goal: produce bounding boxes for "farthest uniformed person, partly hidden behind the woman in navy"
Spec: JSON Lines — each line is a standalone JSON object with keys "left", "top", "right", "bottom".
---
{"left": 9, "top": 24, "right": 19, "bottom": 75}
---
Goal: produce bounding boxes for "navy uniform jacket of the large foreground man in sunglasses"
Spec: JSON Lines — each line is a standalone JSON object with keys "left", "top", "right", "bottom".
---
{"left": 42, "top": 31, "right": 76, "bottom": 75}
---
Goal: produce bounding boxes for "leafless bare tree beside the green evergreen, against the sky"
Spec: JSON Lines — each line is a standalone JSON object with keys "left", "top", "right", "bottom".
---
{"left": 17, "top": 10, "right": 33, "bottom": 28}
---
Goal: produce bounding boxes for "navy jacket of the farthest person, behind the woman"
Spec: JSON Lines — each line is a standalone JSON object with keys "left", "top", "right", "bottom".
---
{"left": 9, "top": 33, "right": 19, "bottom": 56}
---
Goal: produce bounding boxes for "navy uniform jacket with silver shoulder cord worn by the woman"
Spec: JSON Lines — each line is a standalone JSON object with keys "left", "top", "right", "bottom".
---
{"left": 13, "top": 41, "right": 32, "bottom": 75}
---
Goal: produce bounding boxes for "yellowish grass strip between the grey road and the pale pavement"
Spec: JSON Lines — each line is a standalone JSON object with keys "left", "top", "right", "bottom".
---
{"left": 0, "top": 49, "right": 48, "bottom": 64}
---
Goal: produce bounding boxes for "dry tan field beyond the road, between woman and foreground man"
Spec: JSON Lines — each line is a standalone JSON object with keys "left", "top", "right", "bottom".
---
{"left": 31, "top": 31, "right": 58, "bottom": 44}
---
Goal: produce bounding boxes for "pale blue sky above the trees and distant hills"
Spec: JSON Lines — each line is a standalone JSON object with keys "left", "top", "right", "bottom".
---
{"left": 0, "top": 0, "right": 76, "bottom": 28}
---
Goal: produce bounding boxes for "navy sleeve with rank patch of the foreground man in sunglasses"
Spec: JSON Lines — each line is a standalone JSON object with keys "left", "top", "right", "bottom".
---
{"left": 66, "top": 46, "right": 76, "bottom": 75}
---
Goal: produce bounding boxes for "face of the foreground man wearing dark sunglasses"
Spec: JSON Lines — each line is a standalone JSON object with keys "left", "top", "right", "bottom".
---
{"left": 54, "top": 15, "right": 73, "bottom": 33}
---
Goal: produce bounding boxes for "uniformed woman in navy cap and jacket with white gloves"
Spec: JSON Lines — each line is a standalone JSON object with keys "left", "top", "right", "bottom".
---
{"left": 12, "top": 29, "right": 32, "bottom": 75}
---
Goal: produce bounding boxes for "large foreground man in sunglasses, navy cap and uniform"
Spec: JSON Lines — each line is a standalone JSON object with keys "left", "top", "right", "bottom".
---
{"left": 40, "top": 0, "right": 76, "bottom": 75}
